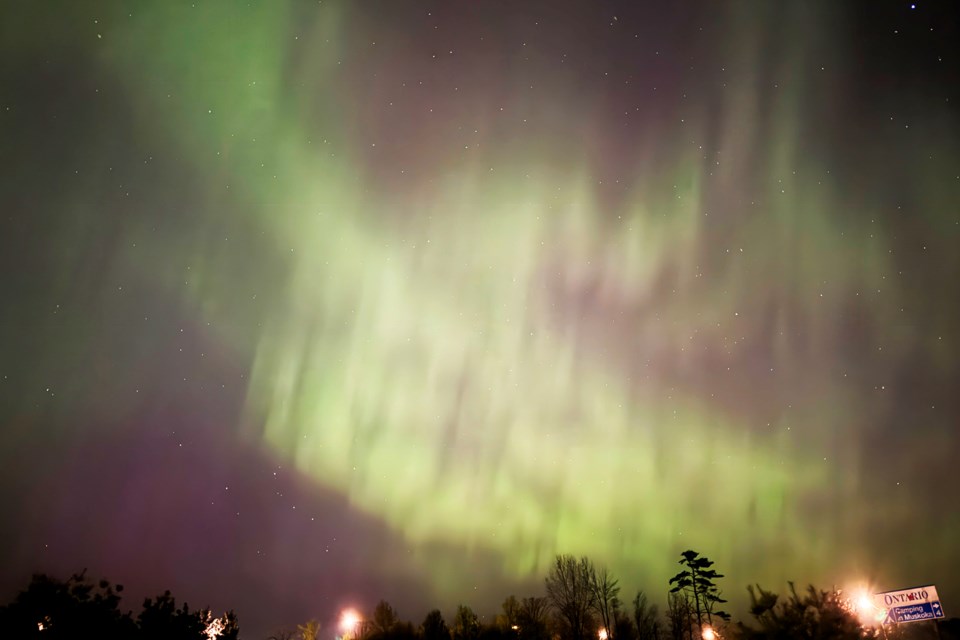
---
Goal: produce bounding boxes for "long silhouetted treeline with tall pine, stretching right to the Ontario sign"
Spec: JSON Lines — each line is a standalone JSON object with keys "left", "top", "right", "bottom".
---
{"left": 282, "top": 550, "right": 960, "bottom": 640}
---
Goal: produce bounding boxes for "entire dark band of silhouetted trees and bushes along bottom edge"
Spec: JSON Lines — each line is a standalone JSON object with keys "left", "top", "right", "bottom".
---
{"left": 0, "top": 551, "right": 960, "bottom": 640}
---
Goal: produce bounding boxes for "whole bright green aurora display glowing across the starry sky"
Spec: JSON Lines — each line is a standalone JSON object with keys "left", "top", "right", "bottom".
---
{"left": 9, "top": 1, "right": 957, "bottom": 608}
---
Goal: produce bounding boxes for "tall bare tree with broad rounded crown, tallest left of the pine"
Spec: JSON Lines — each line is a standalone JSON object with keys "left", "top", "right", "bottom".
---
{"left": 546, "top": 554, "right": 594, "bottom": 640}
